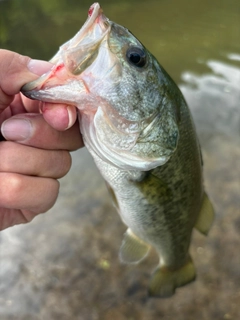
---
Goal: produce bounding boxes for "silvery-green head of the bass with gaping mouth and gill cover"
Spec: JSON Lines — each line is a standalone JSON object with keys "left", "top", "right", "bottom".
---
{"left": 22, "top": 3, "right": 181, "bottom": 171}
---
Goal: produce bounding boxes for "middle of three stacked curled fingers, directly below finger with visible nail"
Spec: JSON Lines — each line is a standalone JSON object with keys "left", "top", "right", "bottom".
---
{"left": 0, "top": 141, "right": 71, "bottom": 179}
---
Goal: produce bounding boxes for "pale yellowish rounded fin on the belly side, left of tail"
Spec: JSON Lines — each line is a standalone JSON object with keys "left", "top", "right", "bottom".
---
{"left": 119, "top": 229, "right": 150, "bottom": 263}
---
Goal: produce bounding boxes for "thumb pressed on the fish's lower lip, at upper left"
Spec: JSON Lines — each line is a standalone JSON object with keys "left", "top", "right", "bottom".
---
{"left": 0, "top": 50, "right": 52, "bottom": 96}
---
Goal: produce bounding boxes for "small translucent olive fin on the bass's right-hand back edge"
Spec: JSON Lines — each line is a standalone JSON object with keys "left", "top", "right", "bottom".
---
{"left": 195, "top": 192, "right": 214, "bottom": 235}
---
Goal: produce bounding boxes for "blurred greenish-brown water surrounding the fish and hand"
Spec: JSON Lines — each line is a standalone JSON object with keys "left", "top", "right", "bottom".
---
{"left": 0, "top": 0, "right": 240, "bottom": 320}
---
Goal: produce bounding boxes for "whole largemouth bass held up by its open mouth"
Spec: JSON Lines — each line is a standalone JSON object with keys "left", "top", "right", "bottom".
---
{"left": 22, "top": 3, "right": 214, "bottom": 297}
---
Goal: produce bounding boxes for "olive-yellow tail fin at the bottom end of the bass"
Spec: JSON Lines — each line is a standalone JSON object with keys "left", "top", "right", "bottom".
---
{"left": 149, "top": 257, "right": 196, "bottom": 298}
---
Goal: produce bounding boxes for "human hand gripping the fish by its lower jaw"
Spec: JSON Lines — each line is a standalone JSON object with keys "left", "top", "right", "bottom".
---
{"left": 0, "top": 50, "right": 83, "bottom": 230}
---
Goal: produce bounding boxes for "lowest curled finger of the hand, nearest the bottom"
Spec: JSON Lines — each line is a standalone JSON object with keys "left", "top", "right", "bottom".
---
{"left": 0, "top": 172, "right": 59, "bottom": 213}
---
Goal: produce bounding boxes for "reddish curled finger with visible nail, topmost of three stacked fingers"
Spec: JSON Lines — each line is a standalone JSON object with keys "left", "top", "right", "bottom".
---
{"left": 1, "top": 114, "right": 83, "bottom": 151}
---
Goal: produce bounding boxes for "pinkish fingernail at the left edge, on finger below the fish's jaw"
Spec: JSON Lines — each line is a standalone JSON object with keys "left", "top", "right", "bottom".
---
{"left": 1, "top": 119, "right": 32, "bottom": 141}
